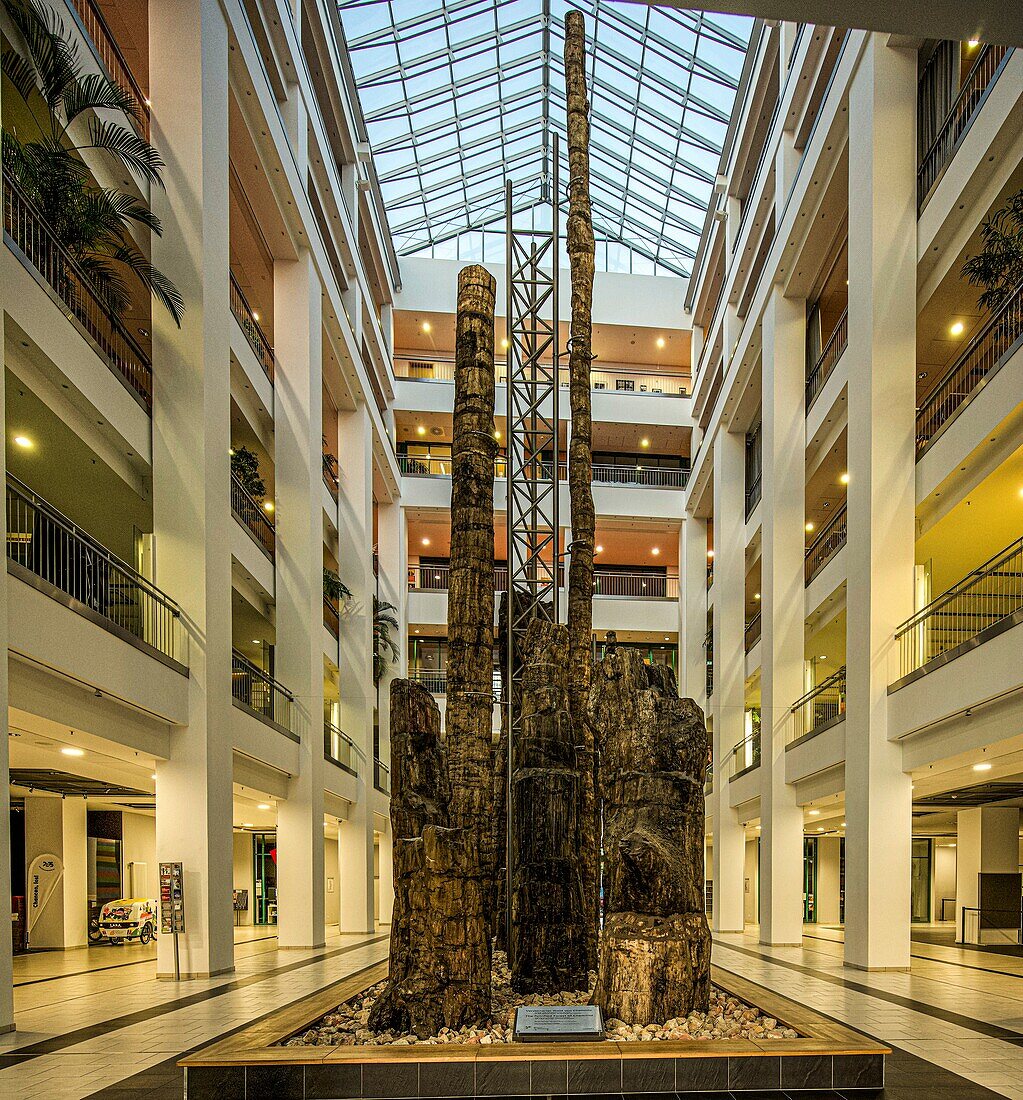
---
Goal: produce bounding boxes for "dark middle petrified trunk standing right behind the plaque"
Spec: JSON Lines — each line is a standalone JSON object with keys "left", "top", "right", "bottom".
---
{"left": 510, "top": 618, "right": 589, "bottom": 993}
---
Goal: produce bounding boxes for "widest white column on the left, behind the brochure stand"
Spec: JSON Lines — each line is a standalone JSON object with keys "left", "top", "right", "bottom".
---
{"left": 150, "top": 0, "right": 234, "bottom": 977}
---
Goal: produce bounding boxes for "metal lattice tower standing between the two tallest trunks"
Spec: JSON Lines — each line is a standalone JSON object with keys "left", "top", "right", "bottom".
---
{"left": 504, "top": 133, "right": 560, "bottom": 948}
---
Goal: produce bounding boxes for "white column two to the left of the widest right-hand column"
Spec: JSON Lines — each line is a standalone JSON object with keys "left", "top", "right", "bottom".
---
{"left": 704, "top": 426, "right": 746, "bottom": 932}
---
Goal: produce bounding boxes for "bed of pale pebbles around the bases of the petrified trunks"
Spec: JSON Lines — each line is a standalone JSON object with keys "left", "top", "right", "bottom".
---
{"left": 279, "top": 952, "right": 798, "bottom": 1046}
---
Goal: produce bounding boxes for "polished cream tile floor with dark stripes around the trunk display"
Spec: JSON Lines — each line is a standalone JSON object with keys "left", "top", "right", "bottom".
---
{"left": 0, "top": 926, "right": 1023, "bottom": 1100}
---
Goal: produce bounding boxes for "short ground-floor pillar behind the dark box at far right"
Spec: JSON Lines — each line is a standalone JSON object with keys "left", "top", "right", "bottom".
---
{"left": 956, "top": 806, "right": 1020, "bottom": 943}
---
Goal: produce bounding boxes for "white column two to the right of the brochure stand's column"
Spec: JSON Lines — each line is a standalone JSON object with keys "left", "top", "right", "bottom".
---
{"left": 338, "top": 405, "right": 376, "bottom": 932}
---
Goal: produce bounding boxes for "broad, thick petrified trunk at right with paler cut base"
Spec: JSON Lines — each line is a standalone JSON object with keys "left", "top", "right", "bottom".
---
{"left": 590, "top": 649, "right": 711, "bottom": 1024}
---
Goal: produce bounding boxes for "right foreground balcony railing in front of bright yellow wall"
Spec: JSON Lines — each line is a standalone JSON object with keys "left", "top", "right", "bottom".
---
{"left": 895, "top": 539, "right": 1023, "bottom": 677}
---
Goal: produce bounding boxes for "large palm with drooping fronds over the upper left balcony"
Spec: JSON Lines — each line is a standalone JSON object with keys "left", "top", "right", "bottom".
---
{"left": 2, "top": 0, "right": 184, "bottom": 323}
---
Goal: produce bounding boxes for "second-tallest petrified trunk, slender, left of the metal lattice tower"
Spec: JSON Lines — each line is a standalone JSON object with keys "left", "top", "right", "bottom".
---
{"left": 437, "top": 265, "right": 497, "bottom": 1018}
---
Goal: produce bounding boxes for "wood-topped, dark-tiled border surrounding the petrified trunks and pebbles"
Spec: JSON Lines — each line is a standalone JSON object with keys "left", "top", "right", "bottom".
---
{"left": 178, "top": 963, "right": 891, "bottom": 1100}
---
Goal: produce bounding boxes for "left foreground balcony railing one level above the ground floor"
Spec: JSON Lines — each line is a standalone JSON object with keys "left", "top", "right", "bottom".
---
{"left": 7, "top": 475, "right": 187, "bottom": 669}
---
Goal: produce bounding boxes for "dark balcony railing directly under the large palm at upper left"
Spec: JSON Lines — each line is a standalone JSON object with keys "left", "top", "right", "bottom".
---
{"left": 3, "top": 173, "right": 153, "bottom": 414}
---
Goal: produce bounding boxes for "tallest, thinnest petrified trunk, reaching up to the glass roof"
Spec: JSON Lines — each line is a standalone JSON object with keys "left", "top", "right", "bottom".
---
{"left": 564, "top": 10, "right": 600, "bottom": 967}
